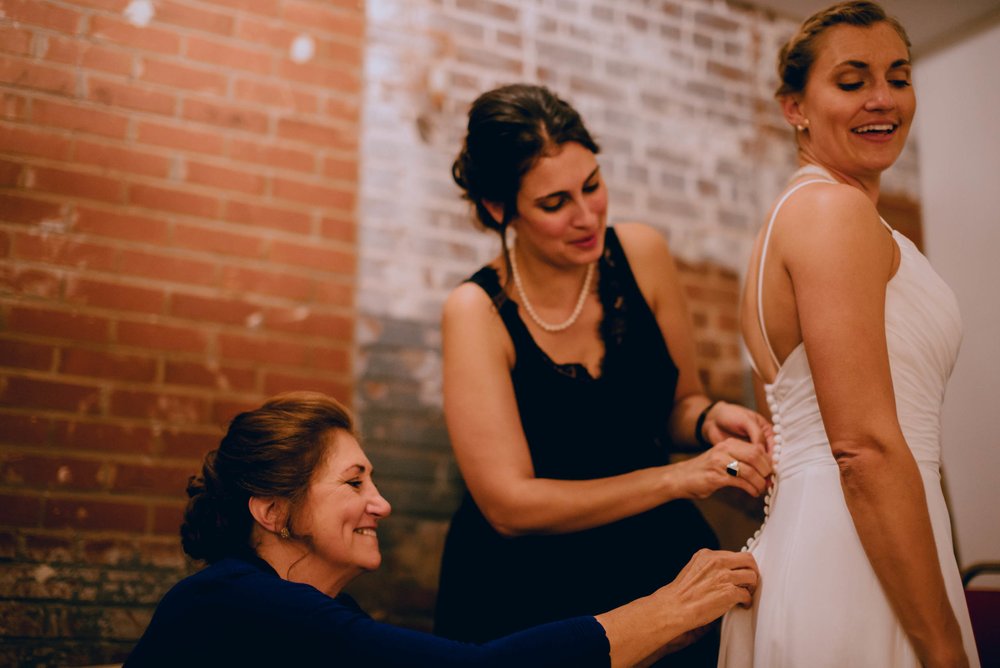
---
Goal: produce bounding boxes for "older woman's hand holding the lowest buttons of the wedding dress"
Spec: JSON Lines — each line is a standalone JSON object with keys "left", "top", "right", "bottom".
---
{"left": 654, "top": 550, "right": 760, "bottom": 629}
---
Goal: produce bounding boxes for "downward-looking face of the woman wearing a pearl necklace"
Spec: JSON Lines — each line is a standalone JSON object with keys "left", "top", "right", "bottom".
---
{"left": 510, "top": 142, "right": 608, "bottom": 266}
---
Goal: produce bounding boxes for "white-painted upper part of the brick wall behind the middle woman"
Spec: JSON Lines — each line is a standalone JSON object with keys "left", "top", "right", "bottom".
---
{"left": 358, "top": 0, "right": 918, "bottom": 326}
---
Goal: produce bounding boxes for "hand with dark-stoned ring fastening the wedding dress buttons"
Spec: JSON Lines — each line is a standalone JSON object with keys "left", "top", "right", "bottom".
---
{"left": 673, "top": 438, "right": 774, "bottom": 499}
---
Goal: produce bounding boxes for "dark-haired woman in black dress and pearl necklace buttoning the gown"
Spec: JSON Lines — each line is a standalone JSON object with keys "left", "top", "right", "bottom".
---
{"left": 435, "top": 84, "right": 771, "bottom": 666}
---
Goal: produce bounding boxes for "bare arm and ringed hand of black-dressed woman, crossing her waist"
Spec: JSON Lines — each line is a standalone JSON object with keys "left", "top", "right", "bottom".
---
{"left": 442, "top": 245, "right": 770, "bottom": 535}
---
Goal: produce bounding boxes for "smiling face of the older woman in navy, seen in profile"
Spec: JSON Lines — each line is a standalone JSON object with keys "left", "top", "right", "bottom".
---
{"left": 295, "top": 429, "right": 391, "bottom": 590}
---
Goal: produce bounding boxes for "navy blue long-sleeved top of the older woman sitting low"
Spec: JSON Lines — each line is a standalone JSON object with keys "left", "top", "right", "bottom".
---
{"left": 126, "top": 560, "right": 610, "bottom": 668}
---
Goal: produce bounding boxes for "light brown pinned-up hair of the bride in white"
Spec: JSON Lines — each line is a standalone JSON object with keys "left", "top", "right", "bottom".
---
{"left": 775, "top": 1, "right": 910, "bottom": 98}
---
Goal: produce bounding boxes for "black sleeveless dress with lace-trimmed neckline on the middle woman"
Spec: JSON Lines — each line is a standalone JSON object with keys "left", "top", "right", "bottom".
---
{"left": 434, "top": 228, "right": 718, "bottom": 666}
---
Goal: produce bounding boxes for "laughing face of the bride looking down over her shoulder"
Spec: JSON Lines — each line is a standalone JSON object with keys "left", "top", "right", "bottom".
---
{"left": 782, "top": 22, "right": 916, "bottom": 180}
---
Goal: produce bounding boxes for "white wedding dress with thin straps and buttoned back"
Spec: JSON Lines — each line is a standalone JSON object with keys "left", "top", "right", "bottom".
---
{"left": 719, "top": 167, "right": 979, "bottom": 668}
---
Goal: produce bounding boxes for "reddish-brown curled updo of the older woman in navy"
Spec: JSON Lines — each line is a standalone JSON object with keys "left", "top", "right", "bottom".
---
{"left": 181, "top": 392, "right": 354, "bottom": 563}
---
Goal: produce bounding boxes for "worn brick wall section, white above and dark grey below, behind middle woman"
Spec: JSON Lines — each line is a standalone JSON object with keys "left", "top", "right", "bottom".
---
{"left": 352, "top": 0, "right": 916, "bottom": 629}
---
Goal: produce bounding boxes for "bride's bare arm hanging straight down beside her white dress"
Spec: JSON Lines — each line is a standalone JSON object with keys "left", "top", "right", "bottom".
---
{"left": 773, "top": 186, "right": 967, "bottom": 666}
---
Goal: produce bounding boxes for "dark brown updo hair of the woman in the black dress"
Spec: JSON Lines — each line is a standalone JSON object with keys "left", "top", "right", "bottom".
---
{"left": 451, "top": 83, "right": 600, "bottom": 237}
